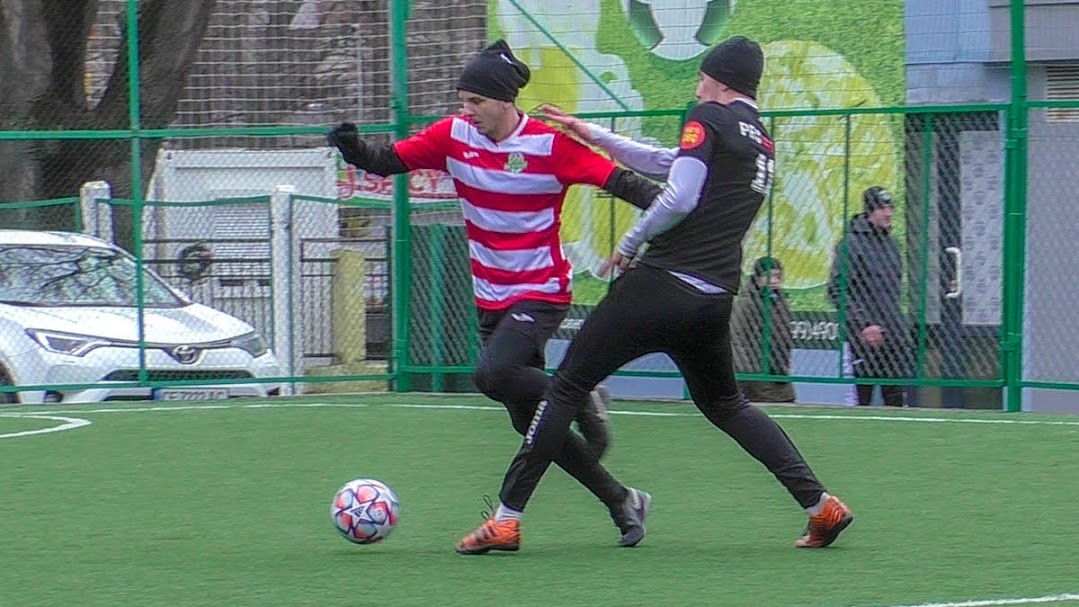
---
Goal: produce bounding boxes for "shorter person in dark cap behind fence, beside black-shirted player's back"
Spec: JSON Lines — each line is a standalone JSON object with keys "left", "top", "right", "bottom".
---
{"left": 730, "top": 257, "right": 794, "bottom": 402}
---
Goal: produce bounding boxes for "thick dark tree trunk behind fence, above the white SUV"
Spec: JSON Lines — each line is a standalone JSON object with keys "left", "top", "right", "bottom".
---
{"left": 0, "top": 0, "right": 217, "bottom": 244}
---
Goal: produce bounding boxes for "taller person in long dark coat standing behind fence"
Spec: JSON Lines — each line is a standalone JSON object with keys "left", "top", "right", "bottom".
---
{"left": 828, "top": 185, "right": 912, "bottom": 406}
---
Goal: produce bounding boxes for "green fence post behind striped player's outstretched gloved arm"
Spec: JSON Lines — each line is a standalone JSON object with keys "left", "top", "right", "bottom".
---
{"left": 390, "top": 0, "right": 412, "bottom": 392}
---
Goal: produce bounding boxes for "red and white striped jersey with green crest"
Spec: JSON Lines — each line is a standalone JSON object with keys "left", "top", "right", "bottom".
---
{"left": 394, "top": 115, "right": 615, "bottom": 311}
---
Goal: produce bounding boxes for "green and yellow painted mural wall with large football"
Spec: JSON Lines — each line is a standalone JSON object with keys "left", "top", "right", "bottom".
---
{"left": 489, "top": 0, "right": 905, "bottom": 311}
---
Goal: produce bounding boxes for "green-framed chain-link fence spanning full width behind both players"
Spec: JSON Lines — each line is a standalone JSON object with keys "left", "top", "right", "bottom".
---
{"left": 0, "top": 0, "right": 1079, "bottom": 408}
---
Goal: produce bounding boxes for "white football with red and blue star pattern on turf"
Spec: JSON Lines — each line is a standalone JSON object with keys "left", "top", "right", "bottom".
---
{"left": 330, "top": 479, "right": 399, "bottom": 543}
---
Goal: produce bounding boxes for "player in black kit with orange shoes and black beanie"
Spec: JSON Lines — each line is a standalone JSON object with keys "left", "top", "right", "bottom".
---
{"left": 457, "top": 37, "right": 853, "bottom": 554}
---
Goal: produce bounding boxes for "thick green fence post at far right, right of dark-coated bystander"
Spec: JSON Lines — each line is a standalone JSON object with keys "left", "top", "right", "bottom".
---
{"left": 1000, "top": 0, "right": 1028, "bottom": 412}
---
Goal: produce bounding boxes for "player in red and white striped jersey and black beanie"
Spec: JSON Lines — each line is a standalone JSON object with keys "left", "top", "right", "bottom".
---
{"left": 327, "top": 40, "right": 660, "bottom": 545}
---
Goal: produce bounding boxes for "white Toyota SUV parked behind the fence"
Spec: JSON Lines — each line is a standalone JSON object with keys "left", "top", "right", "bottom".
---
{"left": 0, "top": 230, "right": 281, "bottom": 403}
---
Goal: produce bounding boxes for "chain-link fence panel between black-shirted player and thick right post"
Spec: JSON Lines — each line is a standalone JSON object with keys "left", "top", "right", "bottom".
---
{"left": 733, "top": 111, "right": 1005, "bottom": 406}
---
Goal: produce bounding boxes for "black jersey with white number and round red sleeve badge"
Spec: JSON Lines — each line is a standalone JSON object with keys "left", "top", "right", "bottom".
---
{"left": 639, "top": 101, "right": 776, "bottom": 293}
